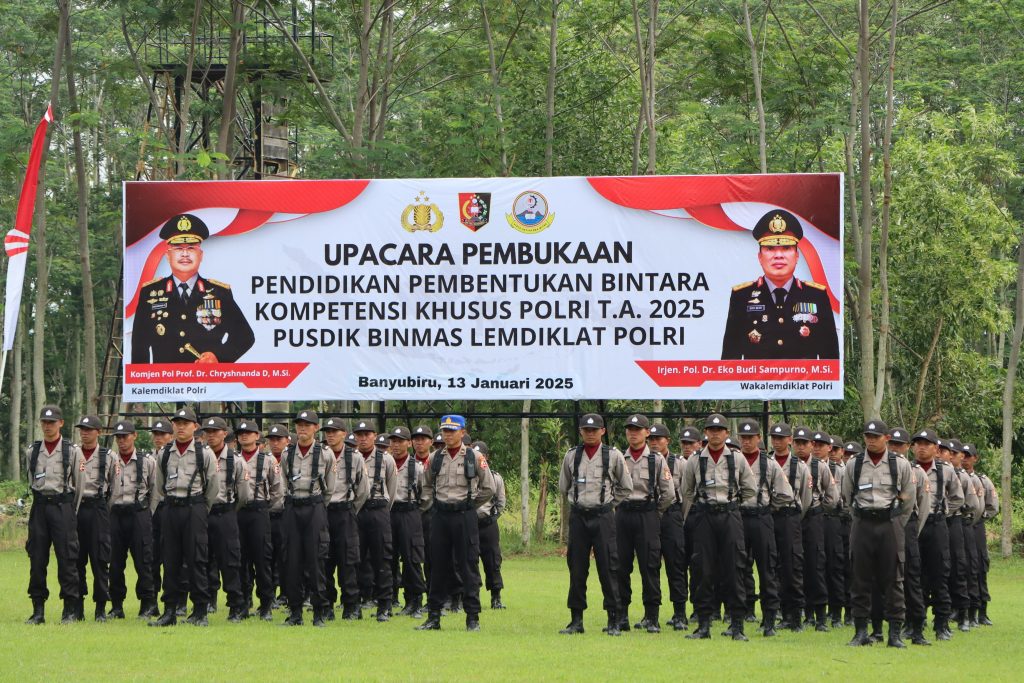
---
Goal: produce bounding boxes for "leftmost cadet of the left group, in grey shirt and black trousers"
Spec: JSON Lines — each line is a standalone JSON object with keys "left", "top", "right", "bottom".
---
{"left": 25, "top": 405, "right": 83, "bottom": 624}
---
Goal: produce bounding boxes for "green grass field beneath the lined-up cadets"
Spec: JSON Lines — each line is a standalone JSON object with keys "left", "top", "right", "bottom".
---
{"left": 0, "top": 551, "right": 1024, "bottom": 682}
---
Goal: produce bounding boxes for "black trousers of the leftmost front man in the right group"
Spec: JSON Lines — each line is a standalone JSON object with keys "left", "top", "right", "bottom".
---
{"left": 565, "top": 509, "right": 618, "bottom": 612}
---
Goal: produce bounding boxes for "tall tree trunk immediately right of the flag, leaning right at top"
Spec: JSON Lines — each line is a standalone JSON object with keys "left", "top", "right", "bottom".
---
{"left": 32, "top": 0, "right": 69, "bottom": 423}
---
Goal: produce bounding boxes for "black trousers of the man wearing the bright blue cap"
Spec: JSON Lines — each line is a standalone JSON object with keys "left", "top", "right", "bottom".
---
{"left": 428, "top": 510, "right": 480, "bottom": 614}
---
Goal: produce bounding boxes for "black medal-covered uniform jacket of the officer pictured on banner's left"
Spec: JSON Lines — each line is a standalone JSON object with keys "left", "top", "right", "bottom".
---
{"left": 131, "top": 276, "right": 256, "bottom": 362}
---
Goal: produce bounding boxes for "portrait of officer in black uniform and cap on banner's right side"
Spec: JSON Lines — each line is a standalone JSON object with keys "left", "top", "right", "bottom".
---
{"left": 722, "top": 209, "right": 839, "bottom": 359}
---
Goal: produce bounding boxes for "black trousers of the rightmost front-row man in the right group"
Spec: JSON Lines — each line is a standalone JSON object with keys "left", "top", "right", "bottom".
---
{"left": 850, "top": 518, "right": 906, "bottom": 622}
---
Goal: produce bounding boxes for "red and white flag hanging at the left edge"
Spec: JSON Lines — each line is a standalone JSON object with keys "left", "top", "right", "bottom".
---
{"left": 3, "top": 105, "right": 53, "bottom": 351}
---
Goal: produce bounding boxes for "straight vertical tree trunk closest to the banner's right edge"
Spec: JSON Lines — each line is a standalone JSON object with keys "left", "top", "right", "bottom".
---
{"left": 857, "top": 0, "right": 878, "bottom": 420}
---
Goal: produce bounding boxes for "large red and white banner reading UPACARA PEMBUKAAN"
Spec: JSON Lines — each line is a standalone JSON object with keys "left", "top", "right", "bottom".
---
{"left": 124, "top": 174, "right": 843, "bottom": 401}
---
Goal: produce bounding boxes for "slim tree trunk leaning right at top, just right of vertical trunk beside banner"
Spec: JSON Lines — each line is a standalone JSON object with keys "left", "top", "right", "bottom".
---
{"left": 871, "top": 0, "right": 899, "bottom": 417}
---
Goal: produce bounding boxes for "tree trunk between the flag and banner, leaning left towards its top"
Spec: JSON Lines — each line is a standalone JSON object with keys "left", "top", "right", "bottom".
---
{"left": 65, "top": 24, "right": 99, "bottom": 413}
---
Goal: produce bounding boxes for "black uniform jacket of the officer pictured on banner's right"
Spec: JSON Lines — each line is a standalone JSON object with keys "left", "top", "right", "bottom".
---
{"left": 722, "top": 276, "right": 839, "bottom": 359}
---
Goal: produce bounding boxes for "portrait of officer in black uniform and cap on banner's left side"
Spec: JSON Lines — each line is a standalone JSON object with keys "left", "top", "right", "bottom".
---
{"left": 131, "top": 213, "right": 256, "bottom": 362}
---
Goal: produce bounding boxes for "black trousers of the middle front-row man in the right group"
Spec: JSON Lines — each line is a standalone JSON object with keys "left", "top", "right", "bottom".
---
{"left": 689, "top": 503, "right": 746, "bottom": 620}
